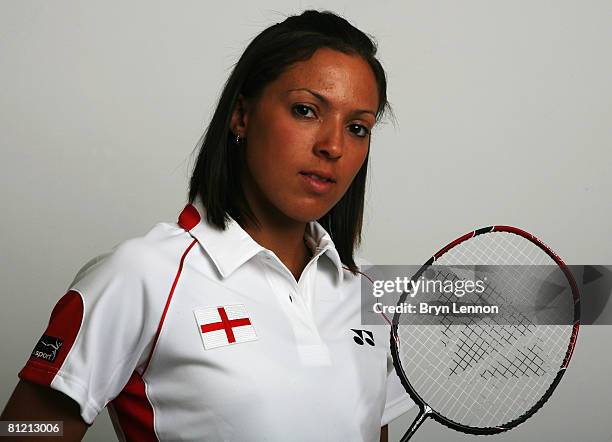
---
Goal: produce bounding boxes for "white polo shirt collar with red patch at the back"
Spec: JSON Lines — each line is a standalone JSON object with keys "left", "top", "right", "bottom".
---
{"left": 178, "top": 199, "right": 344, "bottom": 282}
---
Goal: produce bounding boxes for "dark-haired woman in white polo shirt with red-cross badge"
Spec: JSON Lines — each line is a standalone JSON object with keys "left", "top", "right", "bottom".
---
{"left": 2, "top": 11, "right": 412, "bottom": 441}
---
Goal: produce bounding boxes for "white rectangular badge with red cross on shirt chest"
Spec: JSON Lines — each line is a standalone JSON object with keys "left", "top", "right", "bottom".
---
{"left": 194, "top": 304, "right": 257, "bottom": 350}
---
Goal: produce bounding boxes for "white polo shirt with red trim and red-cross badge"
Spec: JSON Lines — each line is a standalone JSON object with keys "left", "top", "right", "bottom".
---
{"left": 19, "top": 205, "right": 413, "bottom": 441}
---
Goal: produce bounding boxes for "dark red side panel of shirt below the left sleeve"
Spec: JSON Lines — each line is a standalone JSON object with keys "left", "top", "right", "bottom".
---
{"left": 109, "top": 371, "right": 158, "bottom": 442}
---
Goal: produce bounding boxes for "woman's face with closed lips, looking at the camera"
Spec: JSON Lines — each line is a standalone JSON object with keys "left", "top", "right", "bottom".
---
{"left": 232, "top": 48, "right": 378, "bottom": 222}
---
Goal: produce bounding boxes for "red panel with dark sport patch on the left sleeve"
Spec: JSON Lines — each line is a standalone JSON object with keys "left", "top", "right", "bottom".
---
{"left": 19, "top": 290, "right": 83, "bottom": 385}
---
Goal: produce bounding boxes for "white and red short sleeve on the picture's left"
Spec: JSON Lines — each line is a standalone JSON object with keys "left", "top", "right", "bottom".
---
{"left": 19, "top": 242, "right": 161, "bottom": 424}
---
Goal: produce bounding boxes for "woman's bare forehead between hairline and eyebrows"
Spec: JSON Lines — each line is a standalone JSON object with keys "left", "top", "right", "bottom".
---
{"left": 268, "top": 48, "right": 378, "bottom": 110}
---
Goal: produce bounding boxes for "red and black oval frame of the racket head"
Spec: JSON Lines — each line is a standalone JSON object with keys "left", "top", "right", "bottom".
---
{"left": 390, "top": 225, "right": 580, "bottom": 435}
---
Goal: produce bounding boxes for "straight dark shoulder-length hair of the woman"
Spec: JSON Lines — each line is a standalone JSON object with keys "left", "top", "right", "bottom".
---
{"left": 189, "top": 11, "right": 388, "bottom": 272}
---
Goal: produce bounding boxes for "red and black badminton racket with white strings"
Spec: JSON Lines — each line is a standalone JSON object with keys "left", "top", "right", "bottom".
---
{"left": 391, "top": 226, "right": 580, "bottom": 441}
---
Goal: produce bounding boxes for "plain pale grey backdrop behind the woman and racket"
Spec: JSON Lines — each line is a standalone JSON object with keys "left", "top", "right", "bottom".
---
{"left": 0, "top": 0, "right": 612, "bottom": 441}
